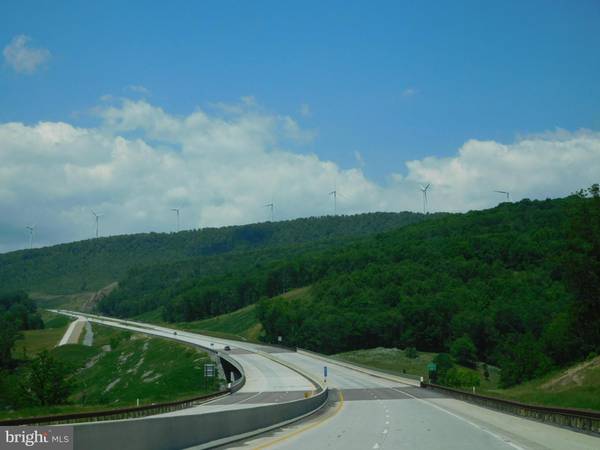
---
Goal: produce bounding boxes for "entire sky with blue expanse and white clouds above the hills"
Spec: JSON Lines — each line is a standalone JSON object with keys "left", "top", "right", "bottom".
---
{"left": 0, "top": 0, "right": 600, "bottom": 252}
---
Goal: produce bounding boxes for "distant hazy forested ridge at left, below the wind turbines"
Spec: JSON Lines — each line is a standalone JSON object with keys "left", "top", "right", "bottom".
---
{"left": 0, "top": 212, "right": 425, "bottom": 294}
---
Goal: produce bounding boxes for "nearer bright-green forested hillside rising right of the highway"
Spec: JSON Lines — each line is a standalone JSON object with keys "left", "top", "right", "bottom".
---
{"left": 257, "top": 189, "right": 600, "bottom": 386}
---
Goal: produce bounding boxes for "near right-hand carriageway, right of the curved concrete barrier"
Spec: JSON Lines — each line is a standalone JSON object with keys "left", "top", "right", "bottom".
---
{"left": 226, "top": 353, "right": 600, "bottom": 450}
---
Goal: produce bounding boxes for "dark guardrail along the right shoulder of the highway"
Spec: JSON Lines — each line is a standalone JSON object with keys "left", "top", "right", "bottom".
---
{"left": 421, "top": 383, "right": 600, "bottom": 434}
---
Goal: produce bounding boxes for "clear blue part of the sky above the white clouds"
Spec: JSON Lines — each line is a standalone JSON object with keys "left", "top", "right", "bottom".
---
{"left": 0, "top": 0, "right": 600, "bottom": 249}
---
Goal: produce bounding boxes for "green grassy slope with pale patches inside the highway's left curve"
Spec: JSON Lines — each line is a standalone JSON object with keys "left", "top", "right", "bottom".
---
{"left": 0, "top": 324, "right": 221, "bottom": 419}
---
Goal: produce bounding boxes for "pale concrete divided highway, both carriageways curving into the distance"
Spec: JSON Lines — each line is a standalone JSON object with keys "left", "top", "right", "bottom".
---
{"left": 54, "top": 313, "right": 600, "bottom": 450}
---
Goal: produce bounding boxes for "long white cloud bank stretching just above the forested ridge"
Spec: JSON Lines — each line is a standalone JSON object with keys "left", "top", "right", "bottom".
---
{"left": 0, "top": 100, "right": 600, "bottom": 251}
